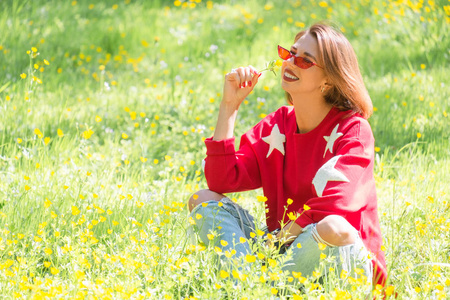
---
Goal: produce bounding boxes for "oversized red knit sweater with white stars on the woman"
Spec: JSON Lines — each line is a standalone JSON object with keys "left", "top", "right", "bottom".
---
{"left": 205, "top": 106, "right": 386, "bottom": 285}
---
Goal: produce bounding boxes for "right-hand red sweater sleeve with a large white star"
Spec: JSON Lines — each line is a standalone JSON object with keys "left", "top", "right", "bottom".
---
{"left": 296, "top": 123, "right": 376, "bottom": 230}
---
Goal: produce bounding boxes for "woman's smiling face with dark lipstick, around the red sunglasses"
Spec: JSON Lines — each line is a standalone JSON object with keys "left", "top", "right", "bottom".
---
{"left": 281, "top": 33, "right": 326, "bottom": 99}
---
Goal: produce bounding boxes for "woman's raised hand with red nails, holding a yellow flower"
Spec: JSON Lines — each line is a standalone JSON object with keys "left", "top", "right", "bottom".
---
{"left": 222, "top": 66, "right": 261, "bottom": 110}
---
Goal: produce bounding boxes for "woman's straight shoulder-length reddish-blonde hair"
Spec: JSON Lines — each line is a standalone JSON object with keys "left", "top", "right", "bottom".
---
{"left": 286, "top": 23, "right": 373, "bottom": 119}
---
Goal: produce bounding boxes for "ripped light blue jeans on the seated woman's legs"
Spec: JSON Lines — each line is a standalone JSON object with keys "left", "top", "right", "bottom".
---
{"left": 191, "top": 198, "right": 373, "bottom": 283}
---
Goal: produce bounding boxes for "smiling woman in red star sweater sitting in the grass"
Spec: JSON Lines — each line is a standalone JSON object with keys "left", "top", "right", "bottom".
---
{"left": 189, "top": 23, "right": 386, "bottom": 284}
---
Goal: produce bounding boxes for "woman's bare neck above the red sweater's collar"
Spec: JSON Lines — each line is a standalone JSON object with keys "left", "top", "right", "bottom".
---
{"left": 292, "top": 98, "right": 332, "bottom": 133}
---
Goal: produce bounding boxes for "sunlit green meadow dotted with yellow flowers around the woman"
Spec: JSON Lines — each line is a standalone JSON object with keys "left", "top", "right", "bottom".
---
{"left": 0, "top": 0, "right": 450, "bottom": 299}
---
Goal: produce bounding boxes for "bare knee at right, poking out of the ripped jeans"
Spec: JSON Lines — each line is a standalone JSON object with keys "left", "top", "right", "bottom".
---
{"left": 316, "top": 215, "right": 356, "bottom": 246}
